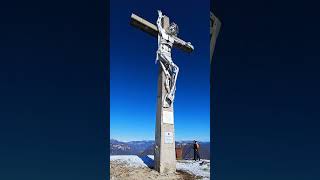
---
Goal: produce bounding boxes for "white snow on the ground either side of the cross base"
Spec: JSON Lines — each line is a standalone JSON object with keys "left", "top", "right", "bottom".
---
{"left": 110, "top": 155, "right": 210, "bottom": 179}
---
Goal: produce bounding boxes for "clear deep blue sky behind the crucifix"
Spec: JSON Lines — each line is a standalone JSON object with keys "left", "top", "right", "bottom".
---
{"left": 110, "top": 0, "right": 210, "bottom": 141}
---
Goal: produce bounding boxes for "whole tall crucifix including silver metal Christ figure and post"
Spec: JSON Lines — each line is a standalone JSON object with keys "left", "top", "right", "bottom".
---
{"left": 130, "top": 10, "right": 194, "bottom": 173}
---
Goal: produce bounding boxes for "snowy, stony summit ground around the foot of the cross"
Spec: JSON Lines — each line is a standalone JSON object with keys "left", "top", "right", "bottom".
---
{"left": 110, "top": 155, "right": 210, "bottom": 180}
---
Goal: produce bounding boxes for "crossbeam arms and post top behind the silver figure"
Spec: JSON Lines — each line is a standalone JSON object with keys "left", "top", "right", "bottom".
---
{"left": 130, "top": 13, "right": 194, "bottom": 53}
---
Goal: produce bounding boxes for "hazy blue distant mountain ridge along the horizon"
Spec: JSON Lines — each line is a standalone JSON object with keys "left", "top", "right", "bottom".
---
{"left": 110, "top": 139, "right": 210, "bottom": 159}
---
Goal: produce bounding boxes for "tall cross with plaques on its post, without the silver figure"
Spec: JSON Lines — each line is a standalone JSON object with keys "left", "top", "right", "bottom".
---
{"left": 130, "top": 11, "right": 194, "bottom": 173}
